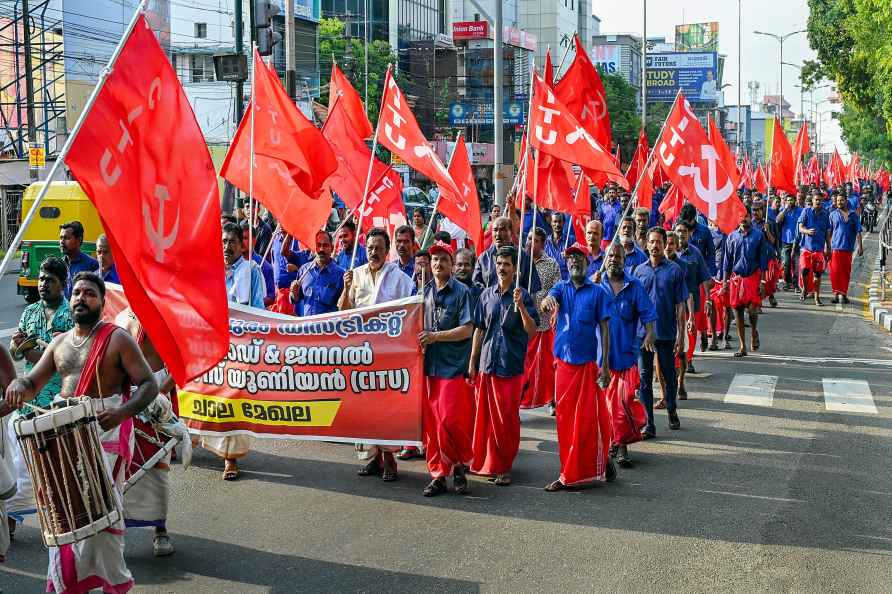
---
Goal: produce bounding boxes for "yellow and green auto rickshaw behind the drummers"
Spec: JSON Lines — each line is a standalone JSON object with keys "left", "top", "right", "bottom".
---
{"left": 17, "top": 181, "right": 103, "bottom": 303}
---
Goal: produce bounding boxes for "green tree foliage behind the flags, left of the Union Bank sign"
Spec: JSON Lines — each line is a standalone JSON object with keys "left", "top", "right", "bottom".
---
{"left": 319, "top": 19, "right": 401, "bottom": 125}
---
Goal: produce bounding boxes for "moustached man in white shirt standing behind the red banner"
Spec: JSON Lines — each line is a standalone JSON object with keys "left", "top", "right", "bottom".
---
{"left": 338, "top": 227, "right": 413, "bottom": 482}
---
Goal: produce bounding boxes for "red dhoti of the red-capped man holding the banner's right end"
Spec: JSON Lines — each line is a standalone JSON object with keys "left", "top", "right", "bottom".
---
{"left": 421, "top": 376, "right": 474, "bottom": 478}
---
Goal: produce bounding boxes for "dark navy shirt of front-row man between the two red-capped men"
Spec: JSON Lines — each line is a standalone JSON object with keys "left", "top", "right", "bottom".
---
{"left": 477, "top": 282, "right": 539, "bottom": 377}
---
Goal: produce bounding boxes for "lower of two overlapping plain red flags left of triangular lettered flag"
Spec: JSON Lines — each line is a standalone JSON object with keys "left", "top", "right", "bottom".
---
{"left": 322, "top": 101, "right": 388, "bottom": 208}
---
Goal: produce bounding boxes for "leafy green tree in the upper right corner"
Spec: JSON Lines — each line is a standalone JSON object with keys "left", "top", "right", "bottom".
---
{"left": 802, "top": 0, "right": 892, "bottom": 164}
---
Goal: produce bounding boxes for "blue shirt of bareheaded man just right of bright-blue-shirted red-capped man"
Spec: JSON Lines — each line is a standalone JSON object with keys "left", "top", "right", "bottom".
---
{"left": 599, "top": 272, "right": 657, "bottom": 371}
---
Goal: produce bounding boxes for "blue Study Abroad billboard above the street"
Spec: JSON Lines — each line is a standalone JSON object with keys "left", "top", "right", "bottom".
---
{"left": 646, "top": 52, "right": 720, "bottom": 103}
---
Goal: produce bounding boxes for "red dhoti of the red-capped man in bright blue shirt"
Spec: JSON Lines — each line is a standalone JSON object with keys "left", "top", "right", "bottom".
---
{"left": 554, "top": 359, "right": 610, "bottom": 485}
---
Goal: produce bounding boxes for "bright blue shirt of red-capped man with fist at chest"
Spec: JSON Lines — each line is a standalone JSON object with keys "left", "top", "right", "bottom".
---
{"left": 548, "top": 279, "right": 613, "bottom": 365}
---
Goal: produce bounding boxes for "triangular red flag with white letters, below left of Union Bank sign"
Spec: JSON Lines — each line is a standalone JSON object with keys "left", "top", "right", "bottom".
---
{"left": 378, "top": 69, "right": 461, "bottom": 201}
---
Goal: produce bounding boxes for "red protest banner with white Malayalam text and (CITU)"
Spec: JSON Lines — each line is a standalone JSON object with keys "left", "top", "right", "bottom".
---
{"left": 104, "top": 285, "right": 424, "bottom": 445}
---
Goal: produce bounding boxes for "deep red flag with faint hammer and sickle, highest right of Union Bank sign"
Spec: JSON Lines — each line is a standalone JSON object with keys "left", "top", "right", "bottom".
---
{"left": 554, "top": 35, "right": 613, "bottom": 150}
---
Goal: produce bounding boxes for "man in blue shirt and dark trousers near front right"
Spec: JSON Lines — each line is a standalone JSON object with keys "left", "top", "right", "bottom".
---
{"left": 635, "top": 227, "right": 688, "bottom": 439}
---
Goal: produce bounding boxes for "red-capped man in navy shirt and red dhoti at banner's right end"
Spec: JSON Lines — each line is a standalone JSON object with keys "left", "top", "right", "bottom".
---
{"left": 418, "top": 241, "right": 474, "bottom": 497}
